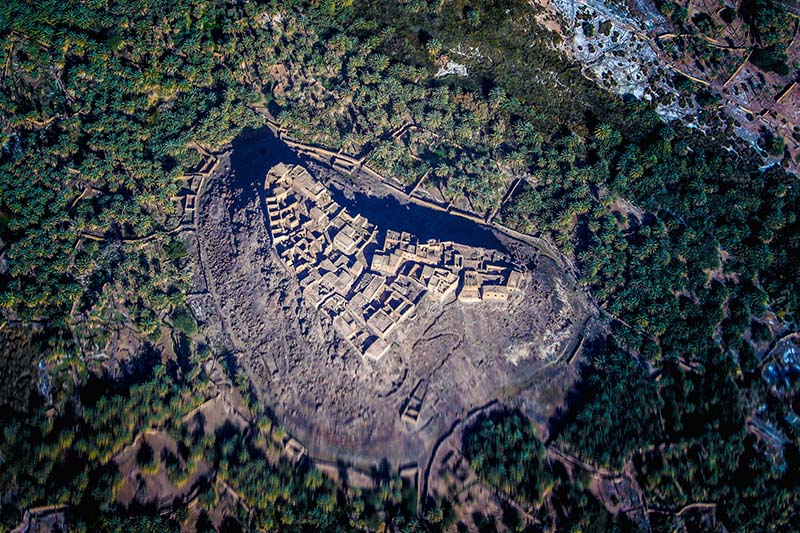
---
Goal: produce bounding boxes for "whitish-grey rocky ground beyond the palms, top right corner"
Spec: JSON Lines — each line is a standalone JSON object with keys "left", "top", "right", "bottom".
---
{"left": 540, "top": 0, "right": 800, "bottom": 173}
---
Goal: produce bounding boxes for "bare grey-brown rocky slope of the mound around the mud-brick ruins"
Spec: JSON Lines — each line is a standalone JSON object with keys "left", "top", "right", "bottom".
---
{"left": 190, "top": 131, "right": 589, "bottom": 480}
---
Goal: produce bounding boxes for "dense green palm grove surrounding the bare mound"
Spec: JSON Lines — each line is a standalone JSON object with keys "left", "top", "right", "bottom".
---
{"left": 0, "top": 0, "right": 800, "bottom": 530}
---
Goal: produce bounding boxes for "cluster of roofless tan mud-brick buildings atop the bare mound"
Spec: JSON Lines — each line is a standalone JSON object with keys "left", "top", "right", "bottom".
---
{"left": 264, "top": 163, "right": 527, "bottom": 360}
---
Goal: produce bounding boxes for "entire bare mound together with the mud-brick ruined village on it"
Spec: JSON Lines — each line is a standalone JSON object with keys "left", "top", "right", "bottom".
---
{"left": 189, "top": 137, "right": 591, "bottom": 488}
